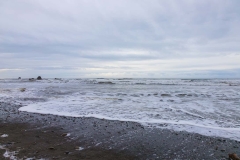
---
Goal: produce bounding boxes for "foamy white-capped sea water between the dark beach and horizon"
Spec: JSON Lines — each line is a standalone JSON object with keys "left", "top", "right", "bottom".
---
{"left": 0, "top": 78, "right": 240, "bottom": 141}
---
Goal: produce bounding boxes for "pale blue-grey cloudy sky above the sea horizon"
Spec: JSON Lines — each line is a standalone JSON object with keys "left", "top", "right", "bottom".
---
{"left": 0, "top": 0, "right": 240, "bottom": 78}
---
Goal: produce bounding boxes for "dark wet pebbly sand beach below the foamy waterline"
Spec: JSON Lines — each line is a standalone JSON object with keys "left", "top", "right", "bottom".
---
{"left": 0, "top": 102, "right": 240, "bottom": 160}
